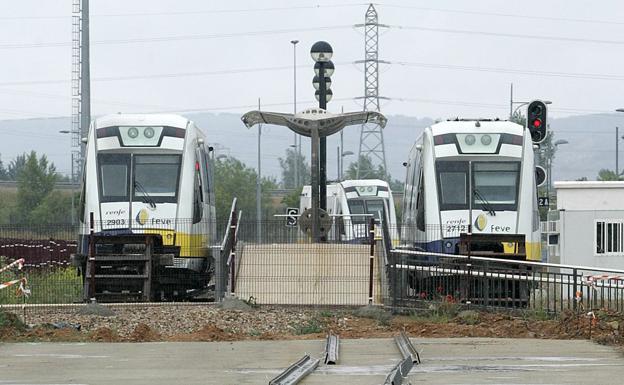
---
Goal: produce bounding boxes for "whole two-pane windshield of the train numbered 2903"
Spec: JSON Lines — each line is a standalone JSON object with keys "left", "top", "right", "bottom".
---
{"left": 98, "top": 154, "right": 181, "bottom": 203}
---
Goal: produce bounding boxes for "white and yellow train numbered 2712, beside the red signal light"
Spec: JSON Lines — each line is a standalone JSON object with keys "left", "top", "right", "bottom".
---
{"left": 401, "top": 119, "right": 541, "bottom": 261}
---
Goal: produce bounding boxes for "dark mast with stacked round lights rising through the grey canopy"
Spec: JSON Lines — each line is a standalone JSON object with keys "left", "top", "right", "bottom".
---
{"left": 310, "top": 41, "right": 334, "bottom": 210}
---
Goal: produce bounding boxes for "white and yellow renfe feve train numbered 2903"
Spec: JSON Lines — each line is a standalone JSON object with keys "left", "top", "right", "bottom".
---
{"left": 74, "top": 114, "right": 216, "bottom": 298}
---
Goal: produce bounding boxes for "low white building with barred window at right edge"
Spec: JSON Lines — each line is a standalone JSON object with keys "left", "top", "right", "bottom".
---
{"left": 543, "top": 181, "right": 624, "bottom": 269}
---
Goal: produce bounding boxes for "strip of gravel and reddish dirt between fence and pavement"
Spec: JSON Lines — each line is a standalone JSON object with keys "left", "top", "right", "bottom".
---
{"left": 0, "top": 305, "right": 624, "bottom": 348}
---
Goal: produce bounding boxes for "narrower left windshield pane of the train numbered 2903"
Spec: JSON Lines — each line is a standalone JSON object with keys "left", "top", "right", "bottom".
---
{"left": 98, "top": 154, "right": 130, "bottom": 202}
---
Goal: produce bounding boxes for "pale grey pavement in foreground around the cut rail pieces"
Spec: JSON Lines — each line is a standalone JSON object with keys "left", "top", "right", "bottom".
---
{"left": 0, "top": 338, "right": 624, "bottom": 385}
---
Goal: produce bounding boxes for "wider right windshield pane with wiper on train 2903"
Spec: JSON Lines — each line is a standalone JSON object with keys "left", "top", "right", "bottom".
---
{"left": 133, "top": 155, "right": 180, "bottom": 203}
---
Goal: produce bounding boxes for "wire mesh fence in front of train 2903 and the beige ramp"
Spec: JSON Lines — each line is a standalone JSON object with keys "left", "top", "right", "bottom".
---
{"left": 0, "top": 214, "right": 381, "bottom": 305}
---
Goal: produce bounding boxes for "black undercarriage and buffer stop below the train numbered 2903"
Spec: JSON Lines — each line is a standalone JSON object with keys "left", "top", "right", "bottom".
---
{"left": 74, "top": 234, "right": 214, "bottom": 302}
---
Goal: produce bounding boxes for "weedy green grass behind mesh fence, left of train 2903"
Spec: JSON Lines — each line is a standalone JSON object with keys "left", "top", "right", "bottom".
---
{"left": 0, "top": 267, "right": 82, "bottom": 304}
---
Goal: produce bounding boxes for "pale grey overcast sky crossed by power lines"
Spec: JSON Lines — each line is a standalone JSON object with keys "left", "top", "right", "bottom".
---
{"left": 0, "top": 0, "right": 624, "bottom": 176}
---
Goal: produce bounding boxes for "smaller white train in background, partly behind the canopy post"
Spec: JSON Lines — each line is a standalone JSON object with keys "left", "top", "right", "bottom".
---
{"left": 299, "top": 179, "right": 399, "bottom": 243}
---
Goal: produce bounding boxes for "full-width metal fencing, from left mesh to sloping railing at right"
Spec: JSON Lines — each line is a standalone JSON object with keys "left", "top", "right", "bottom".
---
{"left": 0, "top": 216, "right": 624, "bottom": 312}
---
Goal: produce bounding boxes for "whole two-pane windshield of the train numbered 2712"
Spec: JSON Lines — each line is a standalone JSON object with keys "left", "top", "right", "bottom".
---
{"left": 436, "top": 161, "right": 520, "bottom": 211}
